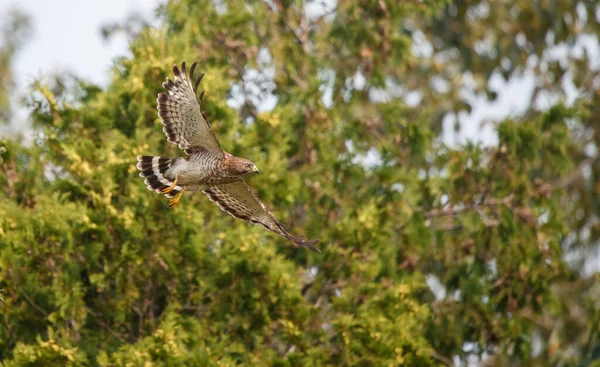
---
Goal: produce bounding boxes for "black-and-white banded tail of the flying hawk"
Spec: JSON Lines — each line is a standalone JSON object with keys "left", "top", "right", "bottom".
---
{"left": 136, "top": 155, "right": 183, "bottom": 198}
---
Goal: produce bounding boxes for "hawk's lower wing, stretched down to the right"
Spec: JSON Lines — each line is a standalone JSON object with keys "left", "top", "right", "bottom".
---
{"left": 203, "top": 180, "right": 321, "bottom": 252}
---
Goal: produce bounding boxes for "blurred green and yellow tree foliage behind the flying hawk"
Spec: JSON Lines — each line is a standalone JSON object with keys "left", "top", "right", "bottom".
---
{"left": 0, "top": 0, "right": 600, "bottom": 366}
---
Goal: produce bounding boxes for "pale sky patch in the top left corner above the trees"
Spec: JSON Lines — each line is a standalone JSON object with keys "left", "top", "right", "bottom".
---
{"left": 0, "top": 0, "right": 164, "bottom": 141}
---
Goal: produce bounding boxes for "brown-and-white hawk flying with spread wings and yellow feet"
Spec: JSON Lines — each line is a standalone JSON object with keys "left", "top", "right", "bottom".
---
{"left": 136, "top": 61, "right": 320, "bottom": 252}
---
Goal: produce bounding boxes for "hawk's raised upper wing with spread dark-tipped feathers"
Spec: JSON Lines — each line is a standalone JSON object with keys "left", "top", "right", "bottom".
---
{"left": 156, "top": 61, "right": 223, "bottom": 154}
